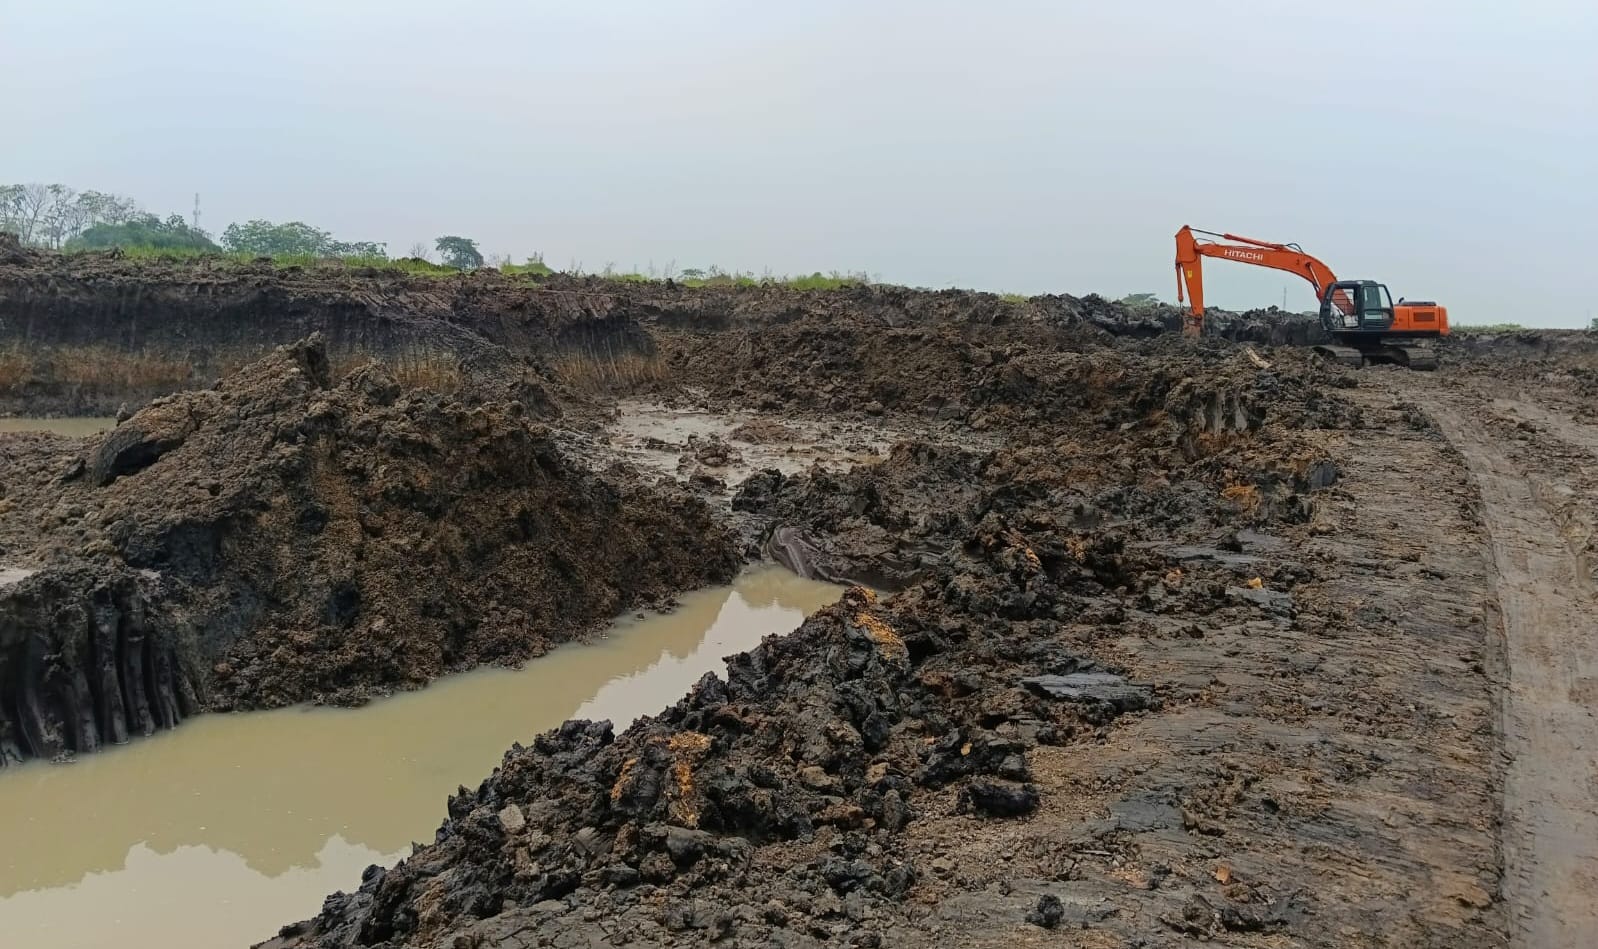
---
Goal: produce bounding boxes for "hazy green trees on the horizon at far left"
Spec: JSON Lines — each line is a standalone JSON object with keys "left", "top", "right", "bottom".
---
{"left": 0, "top": 184, "right": 483, "bottom": 270}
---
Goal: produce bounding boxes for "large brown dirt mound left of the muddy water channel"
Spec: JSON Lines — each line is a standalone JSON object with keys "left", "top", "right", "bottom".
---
{"left": 0, "top": 335, "right": 740, "bottom": 756}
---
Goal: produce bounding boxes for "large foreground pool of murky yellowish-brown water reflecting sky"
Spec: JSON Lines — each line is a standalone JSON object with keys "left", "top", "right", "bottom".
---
{"left": 0, "top": 570, "right": 839, "bottom": 949}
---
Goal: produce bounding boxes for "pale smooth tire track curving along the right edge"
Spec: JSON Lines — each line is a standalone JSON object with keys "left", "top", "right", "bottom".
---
{"left": 1430, "top": 399, "right": 1598, "bottom": 949}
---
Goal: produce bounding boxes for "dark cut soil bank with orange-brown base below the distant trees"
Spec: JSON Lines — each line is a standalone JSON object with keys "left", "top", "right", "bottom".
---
{"left": 0, "top": 238, "right": 650, "bottom": 415}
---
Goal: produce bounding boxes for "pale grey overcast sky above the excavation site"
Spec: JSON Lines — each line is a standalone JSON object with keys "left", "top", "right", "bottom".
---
{"left": 9, "top": 0, "right": 1598, "bottom": 326}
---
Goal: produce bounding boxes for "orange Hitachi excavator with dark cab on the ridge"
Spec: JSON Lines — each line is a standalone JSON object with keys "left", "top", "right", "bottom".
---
{"left": 1176, "top": 225, "right": 1448, "bottom": 369}
